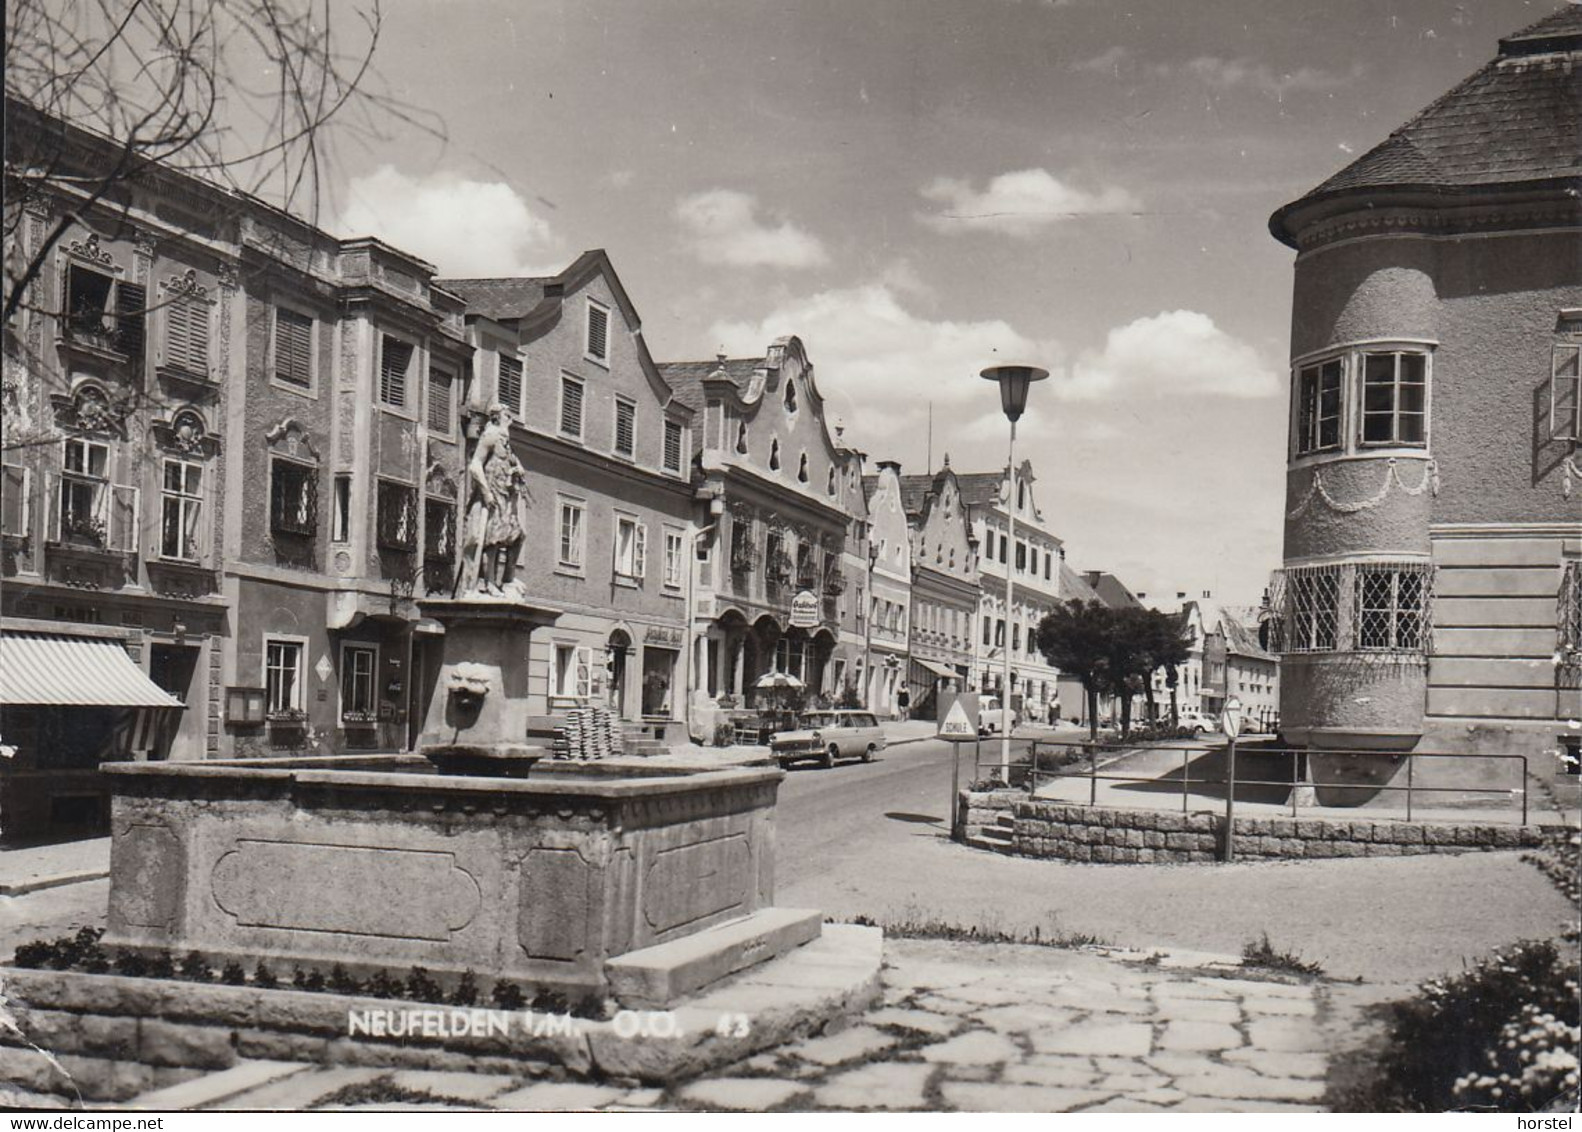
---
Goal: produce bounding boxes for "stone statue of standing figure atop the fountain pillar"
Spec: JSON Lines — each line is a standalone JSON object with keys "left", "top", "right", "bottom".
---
{"left": 456, "top": 403, "right": 527, "bottom": 598}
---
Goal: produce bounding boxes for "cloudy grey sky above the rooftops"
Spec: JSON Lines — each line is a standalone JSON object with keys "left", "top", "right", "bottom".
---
{"left": 308, "top": 0, "right": 1560, "bottom": 606}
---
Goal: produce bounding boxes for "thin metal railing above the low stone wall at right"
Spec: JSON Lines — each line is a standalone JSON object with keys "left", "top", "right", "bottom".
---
{"left": 976, "top": 740, "right": 1528, "bottom": 825}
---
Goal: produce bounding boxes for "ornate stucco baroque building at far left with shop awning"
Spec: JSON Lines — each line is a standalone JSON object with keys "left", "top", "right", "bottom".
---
{"left": 0, "top": 103, "right": 468, "bottom": 835}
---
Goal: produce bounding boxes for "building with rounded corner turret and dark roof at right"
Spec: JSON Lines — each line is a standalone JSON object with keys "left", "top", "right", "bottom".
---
{"left": 1269, "top": 5, "right": 1582, "bottom": 790}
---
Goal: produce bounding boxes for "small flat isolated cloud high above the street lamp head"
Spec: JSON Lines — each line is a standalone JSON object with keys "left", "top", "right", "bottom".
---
{"left": 918, "top": 169, "right": 1141, "bottom": 239}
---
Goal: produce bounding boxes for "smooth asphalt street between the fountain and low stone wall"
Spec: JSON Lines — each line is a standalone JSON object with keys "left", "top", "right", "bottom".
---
{"left": 775, "top": 740, "right": 1576, "bottom": 982}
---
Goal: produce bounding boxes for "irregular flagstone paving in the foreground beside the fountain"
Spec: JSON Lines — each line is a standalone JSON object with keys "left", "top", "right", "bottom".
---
{"left": 181, "top": 939, "right": 1345, "bottom": 1111}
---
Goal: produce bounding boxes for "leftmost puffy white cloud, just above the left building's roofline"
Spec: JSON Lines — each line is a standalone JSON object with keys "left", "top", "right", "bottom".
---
{"left": 337, "top": 164, "right": 563, "bottom": 277}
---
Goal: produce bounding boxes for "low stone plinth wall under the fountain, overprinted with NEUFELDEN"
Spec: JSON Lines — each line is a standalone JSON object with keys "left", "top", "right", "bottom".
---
{"left": 0, "top": 923, "right": 883, "bottom": 1100}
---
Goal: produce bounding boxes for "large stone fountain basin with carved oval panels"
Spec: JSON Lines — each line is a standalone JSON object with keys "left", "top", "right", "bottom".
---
{"left": 104, "top": 756, "right": 781, "bottom": 998}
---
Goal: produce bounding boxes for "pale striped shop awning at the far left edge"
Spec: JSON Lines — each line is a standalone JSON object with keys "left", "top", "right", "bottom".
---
{"left": 0, "top": 629, "right": 185, "bottom": 708}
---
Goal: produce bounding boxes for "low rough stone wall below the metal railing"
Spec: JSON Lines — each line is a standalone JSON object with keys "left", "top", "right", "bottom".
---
{"left": 960, "top": 792, "right": 1542, "bottom": 865}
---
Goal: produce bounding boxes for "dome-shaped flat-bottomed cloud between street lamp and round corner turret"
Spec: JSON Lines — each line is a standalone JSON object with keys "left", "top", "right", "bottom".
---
{"left": 1058, "top": 310, "right": 1280, "bottom": 400}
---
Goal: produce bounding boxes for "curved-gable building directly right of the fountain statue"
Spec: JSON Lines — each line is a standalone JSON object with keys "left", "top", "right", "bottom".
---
{"left": 445, "top": 248, "right": 696, "bottom": 741}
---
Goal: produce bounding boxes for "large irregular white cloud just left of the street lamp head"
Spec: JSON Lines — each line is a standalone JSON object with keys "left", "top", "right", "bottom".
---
{"left": 709, "top": 283, "right": 1058, "bottom": 440}
